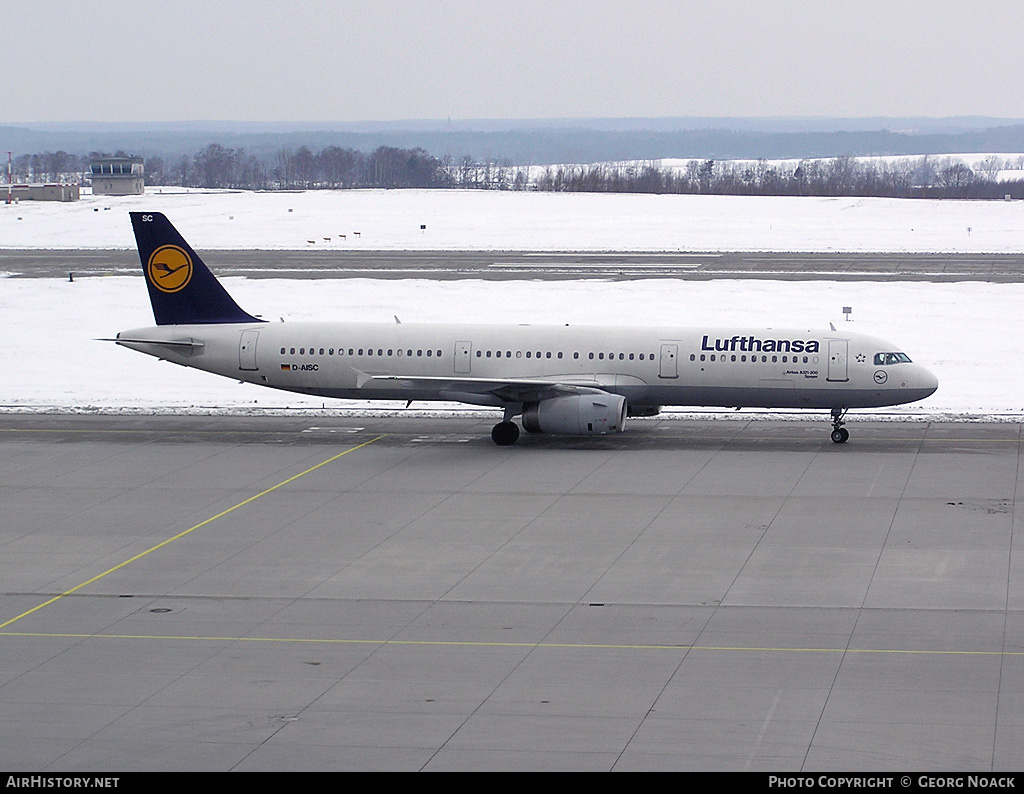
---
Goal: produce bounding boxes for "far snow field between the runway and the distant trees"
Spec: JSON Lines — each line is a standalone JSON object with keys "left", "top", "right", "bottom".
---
{"left": 0, "top": 187, "right": 1024, "bottom": 252}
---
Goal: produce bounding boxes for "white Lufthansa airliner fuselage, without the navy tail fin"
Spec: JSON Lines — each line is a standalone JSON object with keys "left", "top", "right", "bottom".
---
{"left": 119, "top": 323, "right": 938, "bottom": 410}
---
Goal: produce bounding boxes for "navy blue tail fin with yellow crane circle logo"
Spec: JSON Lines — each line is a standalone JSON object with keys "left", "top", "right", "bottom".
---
{"left": 128, "top": 212, "right": 262, "bottom": 326}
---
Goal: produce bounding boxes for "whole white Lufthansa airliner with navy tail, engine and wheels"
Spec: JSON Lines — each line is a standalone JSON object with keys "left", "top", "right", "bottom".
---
{"left": 115, "top": 212, "right": 938, "bottom": 446}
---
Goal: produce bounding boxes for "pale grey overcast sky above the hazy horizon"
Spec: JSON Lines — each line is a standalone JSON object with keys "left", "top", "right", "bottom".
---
{"left": 8, "top": 0, "right": 1024, "bottom": 124}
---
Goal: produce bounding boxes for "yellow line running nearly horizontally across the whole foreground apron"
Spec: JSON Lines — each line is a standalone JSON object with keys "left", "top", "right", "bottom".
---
{"left": 0, "top": 631, "right": 1024, "bottom": 657}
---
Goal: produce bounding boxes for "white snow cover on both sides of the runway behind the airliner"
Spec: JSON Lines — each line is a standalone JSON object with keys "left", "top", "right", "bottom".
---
{"left": 0, "top": 192, "right": 1024, "bottom": 419}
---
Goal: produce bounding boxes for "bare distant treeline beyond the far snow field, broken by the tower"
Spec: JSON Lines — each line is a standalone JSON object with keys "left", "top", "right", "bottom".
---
{"left": 14, "top": 143, "right": 1024, "bottom": 199}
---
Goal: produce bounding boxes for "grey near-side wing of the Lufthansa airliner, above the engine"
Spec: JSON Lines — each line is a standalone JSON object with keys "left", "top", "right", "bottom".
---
{"left": 357, "top": 374, "right": 607, "bottom": 403}
